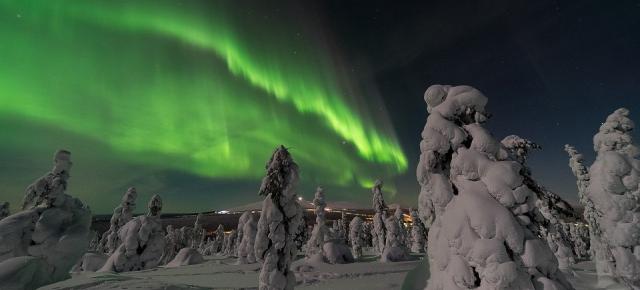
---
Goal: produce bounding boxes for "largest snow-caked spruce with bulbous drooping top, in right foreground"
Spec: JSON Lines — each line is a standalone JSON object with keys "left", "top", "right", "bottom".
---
{"left": 416, "top": 85, "right": 572, "bottom": 289}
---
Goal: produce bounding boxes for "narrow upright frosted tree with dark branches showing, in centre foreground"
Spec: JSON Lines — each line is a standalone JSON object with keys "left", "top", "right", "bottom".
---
{"left": 254, "top": 146, "right": 303, "bottom": 290}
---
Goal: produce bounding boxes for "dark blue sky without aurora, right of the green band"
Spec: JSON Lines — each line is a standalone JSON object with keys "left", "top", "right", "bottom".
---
{"left": 325, "top": 0, "right": 640, "bottom": 202}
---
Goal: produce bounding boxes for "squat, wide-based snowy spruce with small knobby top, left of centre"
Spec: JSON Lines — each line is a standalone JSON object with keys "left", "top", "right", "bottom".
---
{"left": 100, "top": 194, "right": 165, "bottom": 272}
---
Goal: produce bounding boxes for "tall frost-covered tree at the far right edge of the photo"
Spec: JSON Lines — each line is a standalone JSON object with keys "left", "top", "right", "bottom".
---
{"left": 566, "top": 108, "right": 640, "bottom": 289}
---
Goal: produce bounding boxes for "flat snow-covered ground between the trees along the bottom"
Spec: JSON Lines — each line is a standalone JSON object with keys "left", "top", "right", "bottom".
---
{"left": 40, "top": 251, "right": 626, "bottom": 290}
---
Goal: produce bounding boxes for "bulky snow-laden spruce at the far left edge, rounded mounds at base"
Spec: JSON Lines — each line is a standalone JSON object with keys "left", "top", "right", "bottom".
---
{"left": 0, "top": 150, "right": 91, "bottom": 289}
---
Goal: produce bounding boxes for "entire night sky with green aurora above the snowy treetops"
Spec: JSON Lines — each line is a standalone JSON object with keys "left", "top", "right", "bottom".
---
{"left": 0, "top": 0, "right": 640, "bottom": 213}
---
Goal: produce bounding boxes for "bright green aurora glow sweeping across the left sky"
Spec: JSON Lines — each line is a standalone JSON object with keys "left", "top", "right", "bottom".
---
{"left": 0, "top": 0, "right": 407, "bottom": 212}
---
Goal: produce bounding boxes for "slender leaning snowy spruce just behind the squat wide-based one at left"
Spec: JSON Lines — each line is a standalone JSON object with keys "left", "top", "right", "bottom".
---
{"left": 97, "top": 187, "right": 138, "bottom": 255}
